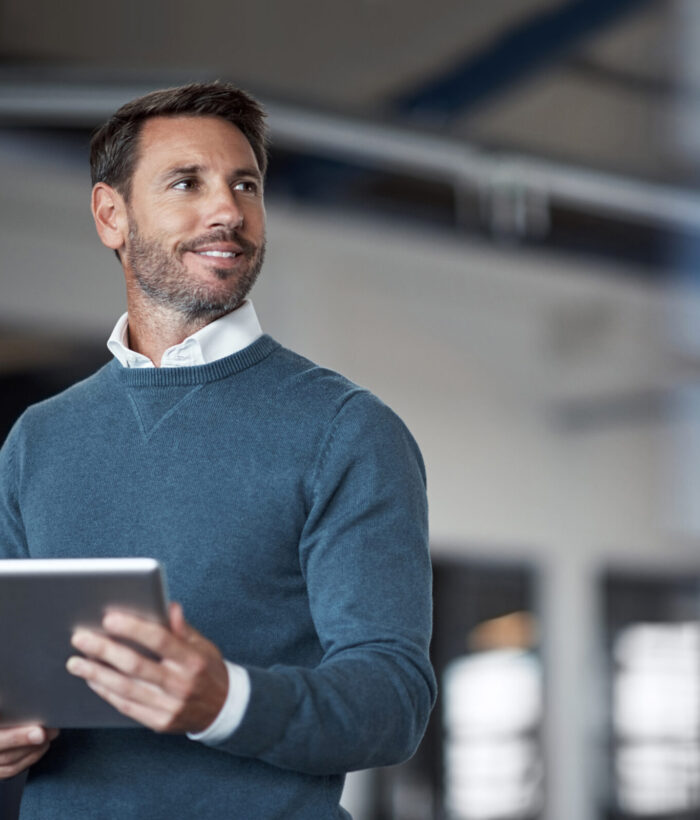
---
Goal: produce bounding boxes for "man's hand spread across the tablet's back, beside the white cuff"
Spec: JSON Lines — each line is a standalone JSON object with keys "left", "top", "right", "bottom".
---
{"left": 66, "top": 604, "right": 228, "bottom": 733}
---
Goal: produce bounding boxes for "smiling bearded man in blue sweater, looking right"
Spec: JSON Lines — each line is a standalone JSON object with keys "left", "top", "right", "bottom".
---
{"left": 0, "top": 83, "right": 435, "bottom": 820}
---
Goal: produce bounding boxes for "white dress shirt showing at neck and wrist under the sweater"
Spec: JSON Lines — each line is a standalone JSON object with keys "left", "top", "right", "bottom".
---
{"left": 107, "top": 299, "right": 262, "bottom": 744}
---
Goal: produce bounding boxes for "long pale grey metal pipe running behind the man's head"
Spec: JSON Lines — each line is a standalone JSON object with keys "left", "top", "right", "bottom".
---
{"left": 0, "top": 77, "right": 700, "bottom": 230}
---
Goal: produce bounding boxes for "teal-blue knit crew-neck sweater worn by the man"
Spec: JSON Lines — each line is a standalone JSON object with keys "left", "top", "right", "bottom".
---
{"left": 0, "top": 336, "right": 435, "bottom": 820}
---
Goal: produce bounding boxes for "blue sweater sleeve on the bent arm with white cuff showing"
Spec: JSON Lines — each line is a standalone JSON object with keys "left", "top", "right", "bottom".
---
{"left": 213, "top": 391, "right": 436, "bottom": 775}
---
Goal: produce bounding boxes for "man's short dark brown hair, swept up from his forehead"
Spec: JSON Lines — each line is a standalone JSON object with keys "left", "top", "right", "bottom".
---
{"left": 90, "top": 81, "right": 267, "bottom": 200}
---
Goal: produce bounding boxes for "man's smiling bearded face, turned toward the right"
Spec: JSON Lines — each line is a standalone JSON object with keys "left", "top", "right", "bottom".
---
{"left": 122, "top": 116, "right": 265, "bottom": 321}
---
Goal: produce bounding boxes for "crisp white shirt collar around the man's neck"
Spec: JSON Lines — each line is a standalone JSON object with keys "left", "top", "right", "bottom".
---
{"left": 107, "top": 299, "right": 262, "bottom": 367}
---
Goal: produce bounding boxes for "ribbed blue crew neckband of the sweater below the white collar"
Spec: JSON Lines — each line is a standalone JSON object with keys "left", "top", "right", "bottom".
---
{"left": 107, "top": 334, "right": 280, "bottom": 387}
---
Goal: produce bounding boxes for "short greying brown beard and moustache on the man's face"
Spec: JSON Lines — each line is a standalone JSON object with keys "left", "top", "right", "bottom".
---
{"left": 127, "top": 216, "right": 265, "bottom": 322}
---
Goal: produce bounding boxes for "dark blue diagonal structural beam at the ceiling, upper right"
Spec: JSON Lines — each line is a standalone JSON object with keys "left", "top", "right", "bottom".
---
{"left": 397, "top": 0, "right": 662, "bottom": 123}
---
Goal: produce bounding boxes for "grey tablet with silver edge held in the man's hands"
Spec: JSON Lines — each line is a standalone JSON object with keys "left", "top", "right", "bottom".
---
{"left": 0, "top": 558, "right": 167, "bottom": 728}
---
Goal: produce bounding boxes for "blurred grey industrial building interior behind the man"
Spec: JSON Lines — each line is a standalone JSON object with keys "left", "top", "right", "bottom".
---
{"left": 0, "top": 0, "right": 700, "bottom": 820}
